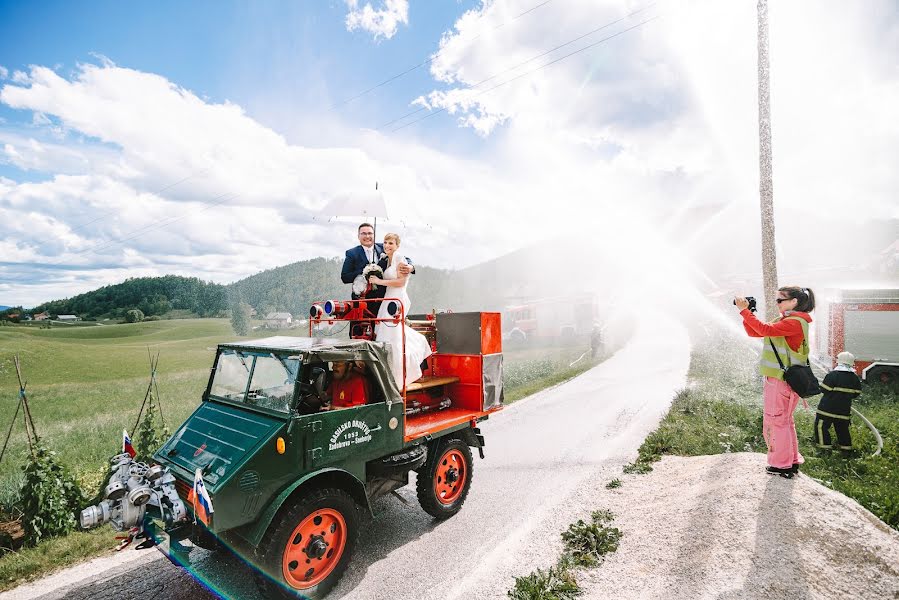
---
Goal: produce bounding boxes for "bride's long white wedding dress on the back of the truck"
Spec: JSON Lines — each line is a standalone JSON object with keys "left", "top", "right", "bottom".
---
{"left": 375, "top": 254, "right": 431, "bottom": 389}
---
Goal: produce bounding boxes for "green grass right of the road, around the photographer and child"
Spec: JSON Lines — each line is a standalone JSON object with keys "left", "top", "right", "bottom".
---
{"left": 625, "top": 328, "right": 899, "bottom": 529}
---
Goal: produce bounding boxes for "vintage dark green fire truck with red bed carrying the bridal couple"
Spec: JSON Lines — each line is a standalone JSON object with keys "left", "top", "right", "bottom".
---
{"left": 81, "top": 299, "right": 503, "bottom": 598}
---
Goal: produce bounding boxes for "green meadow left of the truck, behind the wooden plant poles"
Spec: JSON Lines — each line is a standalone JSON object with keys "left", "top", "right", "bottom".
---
{"left": 0, "top": 319, "right": 255, "bottom": 506}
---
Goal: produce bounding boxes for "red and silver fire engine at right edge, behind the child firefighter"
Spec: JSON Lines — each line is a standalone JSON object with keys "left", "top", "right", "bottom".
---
{"left": 812, "top": 289, "right": 899, "bottom": 383}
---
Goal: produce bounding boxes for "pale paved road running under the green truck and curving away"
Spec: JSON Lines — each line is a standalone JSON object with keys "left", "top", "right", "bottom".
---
{"left": 0, "top": 313, "right": 690, "bottom": 600}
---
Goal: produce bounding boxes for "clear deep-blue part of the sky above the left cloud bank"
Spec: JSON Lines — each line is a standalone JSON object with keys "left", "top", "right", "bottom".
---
{"left": 0, "top": 0, "right": 481, "bottom": 179}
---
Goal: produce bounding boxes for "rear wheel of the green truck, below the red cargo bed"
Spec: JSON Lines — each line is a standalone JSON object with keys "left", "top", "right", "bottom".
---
{"left": 416, "top": 437, "right": 472, "bottom": 519}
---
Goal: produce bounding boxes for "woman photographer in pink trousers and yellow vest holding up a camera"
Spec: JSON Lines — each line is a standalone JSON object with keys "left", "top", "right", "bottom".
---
{"left": 734, "top": 286, "right": 815, "bottom": 479}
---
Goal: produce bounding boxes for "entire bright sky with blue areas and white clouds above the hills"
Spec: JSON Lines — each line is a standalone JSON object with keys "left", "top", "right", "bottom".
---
{"left": 0, "top": 0, "right": 899, "bottom": 307}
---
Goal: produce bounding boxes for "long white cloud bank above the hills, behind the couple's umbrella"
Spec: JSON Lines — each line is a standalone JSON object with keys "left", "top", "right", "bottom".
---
{"left": 0, "top": 65, "right": 536, "bottom": 304}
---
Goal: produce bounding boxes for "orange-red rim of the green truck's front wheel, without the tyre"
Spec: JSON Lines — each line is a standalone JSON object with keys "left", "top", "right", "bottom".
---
{"left": 281, "top": 508, "right": 347, "bottom": 590}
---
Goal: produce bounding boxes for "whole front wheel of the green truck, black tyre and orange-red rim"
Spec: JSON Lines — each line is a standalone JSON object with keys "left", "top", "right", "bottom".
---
{"left": 257, "top": 489, "right": 359, "bottom": 599}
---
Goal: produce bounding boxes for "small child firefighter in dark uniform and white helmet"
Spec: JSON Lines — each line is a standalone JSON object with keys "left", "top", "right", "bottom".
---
{"left": 815, "top": 352, "right": 862, "bottom": 450}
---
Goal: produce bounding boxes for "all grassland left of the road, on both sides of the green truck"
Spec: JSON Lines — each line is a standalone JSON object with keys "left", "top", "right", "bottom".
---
{"left": 0, "top": 319, "right": 597, "bottom": 591}
